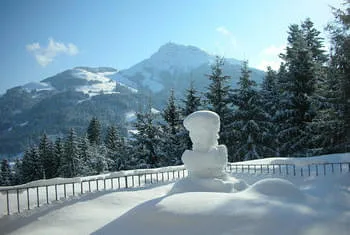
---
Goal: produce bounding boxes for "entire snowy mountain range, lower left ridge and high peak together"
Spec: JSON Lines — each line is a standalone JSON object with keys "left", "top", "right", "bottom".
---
{"left": 0, "top": 43, "right": 264, "bottom": 155}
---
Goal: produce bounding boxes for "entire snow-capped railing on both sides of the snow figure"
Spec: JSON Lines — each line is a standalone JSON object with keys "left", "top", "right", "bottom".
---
{"left": 0, "top": 162, "right": 350, "bottom": 217}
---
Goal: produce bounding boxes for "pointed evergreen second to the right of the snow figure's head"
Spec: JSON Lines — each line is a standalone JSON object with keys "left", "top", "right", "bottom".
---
{"left": 232, "top": 61, "right": 273, "bottom": 161}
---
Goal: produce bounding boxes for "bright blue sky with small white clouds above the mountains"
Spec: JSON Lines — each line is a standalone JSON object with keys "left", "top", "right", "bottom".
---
{"left": 0, "top": 0, "right": 340, "bottom": 93}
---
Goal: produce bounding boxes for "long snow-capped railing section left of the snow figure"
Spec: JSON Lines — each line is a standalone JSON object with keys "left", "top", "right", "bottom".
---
{"left": 0, "top": 166, "right": 187, "bottom": 217}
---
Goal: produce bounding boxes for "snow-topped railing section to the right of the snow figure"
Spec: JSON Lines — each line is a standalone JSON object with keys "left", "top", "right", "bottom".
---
{"left": 226, "top": 162, "right": 350, "bottom": 177}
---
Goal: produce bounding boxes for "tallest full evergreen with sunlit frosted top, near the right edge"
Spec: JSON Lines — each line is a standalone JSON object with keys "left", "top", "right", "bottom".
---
{"left": 277, "top": 20, "right": 324, "bottom": 156}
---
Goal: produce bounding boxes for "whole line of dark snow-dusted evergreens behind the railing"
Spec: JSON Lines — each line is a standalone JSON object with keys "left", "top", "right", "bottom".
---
{"left": 0, "top": 0, "right": 350, "bottom": 185}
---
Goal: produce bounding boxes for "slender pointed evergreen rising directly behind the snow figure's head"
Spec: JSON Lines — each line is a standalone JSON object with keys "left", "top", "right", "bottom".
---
{"left": 205, "top": 57, "right": 233, "bottom": 156}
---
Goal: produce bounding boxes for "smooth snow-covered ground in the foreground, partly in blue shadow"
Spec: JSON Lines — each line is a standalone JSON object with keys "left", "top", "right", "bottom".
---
{"left": 0, "top": 154, "right": 350, "bottom": 235}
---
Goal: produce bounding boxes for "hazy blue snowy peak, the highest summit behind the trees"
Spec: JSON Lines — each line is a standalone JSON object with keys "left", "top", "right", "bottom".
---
{"left": 110, "top": 43, "right": 264, "bottom": 103}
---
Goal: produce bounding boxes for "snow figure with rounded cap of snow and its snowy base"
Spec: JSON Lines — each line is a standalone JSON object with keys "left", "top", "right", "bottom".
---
{"left": 168, "top": 110, "right": 247, "bottom": 195}
